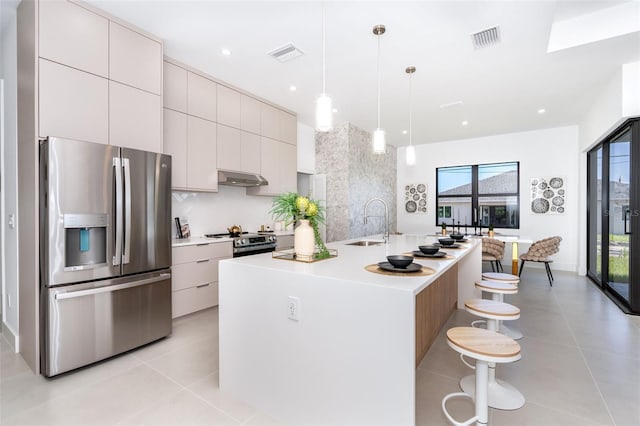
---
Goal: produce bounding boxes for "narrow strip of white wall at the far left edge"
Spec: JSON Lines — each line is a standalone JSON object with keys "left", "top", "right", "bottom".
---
{"left": 0, "top": 1, "right": 19, "bottom": 349}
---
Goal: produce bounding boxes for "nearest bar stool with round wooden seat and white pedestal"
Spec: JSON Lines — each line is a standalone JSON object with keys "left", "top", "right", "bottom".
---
{"left": 442, "top": 327, "right": 521, "bottom": 426}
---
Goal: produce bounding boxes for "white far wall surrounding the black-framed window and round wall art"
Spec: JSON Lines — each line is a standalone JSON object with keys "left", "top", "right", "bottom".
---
{"left": 397, "top": 126, "right": 582, "bottom": 271}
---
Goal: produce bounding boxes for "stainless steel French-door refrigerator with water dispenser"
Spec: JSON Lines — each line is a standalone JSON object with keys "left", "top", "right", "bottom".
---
{"left": 40, "top": 137, "right": 171, "bottom": 376}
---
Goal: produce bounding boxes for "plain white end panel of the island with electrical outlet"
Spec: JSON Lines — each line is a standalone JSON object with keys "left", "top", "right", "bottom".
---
{"left": 219, "top": 260, "right": 415, "bottom": 425}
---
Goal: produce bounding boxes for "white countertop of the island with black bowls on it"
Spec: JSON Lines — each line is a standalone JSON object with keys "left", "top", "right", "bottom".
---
{"left": 223, "top": 234, "right": 480, "bottom": 294}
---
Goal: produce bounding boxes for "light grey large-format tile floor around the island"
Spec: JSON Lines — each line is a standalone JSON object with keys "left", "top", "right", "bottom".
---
{"left": 0, "top": 268, "right": 640, "bottom": 426}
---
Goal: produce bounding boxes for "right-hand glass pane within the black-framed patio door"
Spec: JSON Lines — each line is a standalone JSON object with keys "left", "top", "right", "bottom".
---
{"left": 607, "top": 128, "right": 631, "bottom": 303}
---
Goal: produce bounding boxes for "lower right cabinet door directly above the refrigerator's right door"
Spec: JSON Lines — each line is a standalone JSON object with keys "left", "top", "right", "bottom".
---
{"left": 109, "top": 81, "right": 162, "bottom": 152}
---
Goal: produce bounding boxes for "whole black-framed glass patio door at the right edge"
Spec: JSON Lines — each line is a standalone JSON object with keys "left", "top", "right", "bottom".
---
{"left": 587, "top": 119, "right": 640, "bottom": 314}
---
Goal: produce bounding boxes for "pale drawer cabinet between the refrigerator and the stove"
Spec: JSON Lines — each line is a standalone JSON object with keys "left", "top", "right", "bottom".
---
{"left": 171, "top": 242, "right": 233, "bottom": 318}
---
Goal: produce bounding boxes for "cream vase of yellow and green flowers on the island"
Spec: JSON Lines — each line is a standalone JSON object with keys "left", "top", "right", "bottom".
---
{"left": 270, "top": 192, "right": 329, "bottom": 259}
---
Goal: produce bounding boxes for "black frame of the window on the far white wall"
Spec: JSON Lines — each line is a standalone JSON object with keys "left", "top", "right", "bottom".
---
{"left": 435, "top": 161, "right": 521, "bottom": 229}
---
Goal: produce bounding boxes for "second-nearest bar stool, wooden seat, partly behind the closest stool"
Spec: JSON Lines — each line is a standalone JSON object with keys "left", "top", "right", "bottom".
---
{"left": 460, "top": 299, "right": 525, "bottom": 410}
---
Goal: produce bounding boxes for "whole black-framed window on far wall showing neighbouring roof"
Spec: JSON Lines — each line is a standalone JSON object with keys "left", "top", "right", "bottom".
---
{"left": 436, "top": 162, "right": 520, "bottom": 228}
